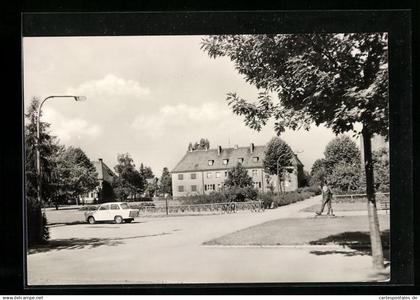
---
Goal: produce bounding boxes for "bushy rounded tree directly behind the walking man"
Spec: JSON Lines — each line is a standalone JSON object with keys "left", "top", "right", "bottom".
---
{"left": 324, "top": 135, "right": 361, "bottom": 192}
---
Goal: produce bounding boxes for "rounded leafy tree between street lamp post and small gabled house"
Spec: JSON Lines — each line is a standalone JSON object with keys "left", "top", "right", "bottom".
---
{"left": 53, "top": 147, "right": 98, "bottom": 207}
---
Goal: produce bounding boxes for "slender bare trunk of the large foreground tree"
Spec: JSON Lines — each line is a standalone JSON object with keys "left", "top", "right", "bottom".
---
{"left": 362, "top": 127, "right": 384, "bottom": 269}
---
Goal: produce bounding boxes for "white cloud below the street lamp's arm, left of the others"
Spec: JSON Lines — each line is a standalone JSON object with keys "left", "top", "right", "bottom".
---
{"left": 43, "top": 108, "right": 102, "bottom": 143}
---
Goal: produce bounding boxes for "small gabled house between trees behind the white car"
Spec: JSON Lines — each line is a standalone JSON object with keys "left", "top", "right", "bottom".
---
{"left": 79, "top": 158, "right": 116, "bottom": 204}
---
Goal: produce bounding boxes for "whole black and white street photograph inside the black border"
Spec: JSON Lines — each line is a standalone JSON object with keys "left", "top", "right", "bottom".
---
{"left": 22, "top": 32, "right": 393, "bottom": 287}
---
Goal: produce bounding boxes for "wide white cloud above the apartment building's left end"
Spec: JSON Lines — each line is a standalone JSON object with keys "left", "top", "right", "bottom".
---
{"left": 131, "top": 102, "right": 231, "bottom": 136}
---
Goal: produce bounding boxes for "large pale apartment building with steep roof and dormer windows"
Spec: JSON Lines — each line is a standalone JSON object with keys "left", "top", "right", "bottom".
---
{"left": 171, "top": 144, "right": 303, "bottom": 198}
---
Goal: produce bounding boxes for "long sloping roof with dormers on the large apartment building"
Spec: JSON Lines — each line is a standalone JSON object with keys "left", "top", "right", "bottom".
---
{"left": 171, "top": 146, "right": 301, "bottom": 173}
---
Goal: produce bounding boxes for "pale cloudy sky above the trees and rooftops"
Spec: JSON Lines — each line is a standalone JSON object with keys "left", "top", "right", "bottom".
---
{"left": 23, "top": 36, "right": 334, "bottom": 176}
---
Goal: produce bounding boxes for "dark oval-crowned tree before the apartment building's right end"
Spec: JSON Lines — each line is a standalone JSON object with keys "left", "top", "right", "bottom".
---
{"left": 263, "top": 137, "right": 293, "bottom": 192}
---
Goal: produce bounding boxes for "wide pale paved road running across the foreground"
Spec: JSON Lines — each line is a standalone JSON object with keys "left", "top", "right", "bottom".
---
{"left": 28, "top": 197, "right": 390, "bottom": 285}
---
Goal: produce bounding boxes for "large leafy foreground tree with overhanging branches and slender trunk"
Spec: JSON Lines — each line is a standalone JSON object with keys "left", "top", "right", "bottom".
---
{"left": 201, "top": 33, "right": 389, "bottom": 269}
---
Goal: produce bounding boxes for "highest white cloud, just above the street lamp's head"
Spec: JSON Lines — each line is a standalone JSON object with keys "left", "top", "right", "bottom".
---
{"left": 67, "top": 74, "right": 150, "bottom": 101}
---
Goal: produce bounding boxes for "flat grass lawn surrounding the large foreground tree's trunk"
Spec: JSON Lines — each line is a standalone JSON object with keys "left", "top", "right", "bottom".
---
{"left": 204, "top": 215, "right": 389, "bottom": 247}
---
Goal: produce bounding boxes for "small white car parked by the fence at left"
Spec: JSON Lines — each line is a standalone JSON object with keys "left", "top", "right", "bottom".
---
{"left": 85, "top": 202, "right": 139, "bottom": 224}
